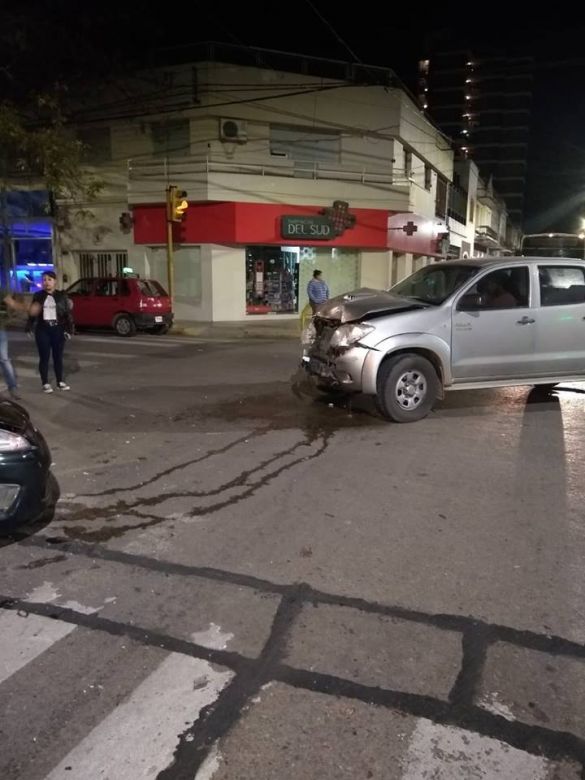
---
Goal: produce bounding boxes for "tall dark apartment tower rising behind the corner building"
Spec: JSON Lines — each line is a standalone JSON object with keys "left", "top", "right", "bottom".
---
{"left": 418, "top": 49, "right": 533, "bottom": 224}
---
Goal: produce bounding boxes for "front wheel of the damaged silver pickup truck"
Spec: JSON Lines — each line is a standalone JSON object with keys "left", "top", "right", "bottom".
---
{"left": 377, "top": 353, "right": 440, "bottom": 423}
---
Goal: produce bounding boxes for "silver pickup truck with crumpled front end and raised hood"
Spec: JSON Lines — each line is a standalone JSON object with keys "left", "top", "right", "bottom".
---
{"left": 302, "top": 257, "right": 585, "bottom": 422}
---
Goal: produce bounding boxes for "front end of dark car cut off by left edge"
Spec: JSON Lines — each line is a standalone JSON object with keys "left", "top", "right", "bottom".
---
{"left": 0, "top": 400, "right": 59, "bottom": 535}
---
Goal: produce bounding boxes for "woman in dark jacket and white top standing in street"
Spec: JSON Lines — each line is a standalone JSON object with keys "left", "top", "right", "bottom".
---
{"left": 27, "top": 271, "right": 73, "bottom": 393}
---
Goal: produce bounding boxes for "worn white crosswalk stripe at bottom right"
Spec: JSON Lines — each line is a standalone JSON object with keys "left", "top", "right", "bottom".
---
{"left": 402, "top": 718, "right": 550, "bottom": 780}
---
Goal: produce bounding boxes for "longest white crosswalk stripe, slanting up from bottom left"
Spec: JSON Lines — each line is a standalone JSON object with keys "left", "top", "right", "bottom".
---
{"left": 46, "top": 653, "right": 232, "bottom": 780}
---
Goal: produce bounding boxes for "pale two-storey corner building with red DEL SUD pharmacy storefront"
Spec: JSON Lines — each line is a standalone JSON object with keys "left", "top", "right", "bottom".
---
{"left": 56, "top": 47, "right": 456, "bottom": 322}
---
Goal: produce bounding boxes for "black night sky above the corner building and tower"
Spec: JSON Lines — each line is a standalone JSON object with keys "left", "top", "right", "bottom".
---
{"left": 8, "top": 0, "right": 585, "bottom": 231}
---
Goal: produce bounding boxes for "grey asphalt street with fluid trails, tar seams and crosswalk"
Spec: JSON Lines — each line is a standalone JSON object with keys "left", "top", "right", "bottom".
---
{"left": 0, "top": 334, "right": 585, "bottom": 780}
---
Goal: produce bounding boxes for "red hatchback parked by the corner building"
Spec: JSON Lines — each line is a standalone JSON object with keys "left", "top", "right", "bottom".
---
{"left": 66, "top": 277, "right": 173, "bottom": 336}
